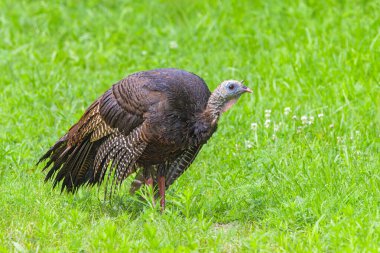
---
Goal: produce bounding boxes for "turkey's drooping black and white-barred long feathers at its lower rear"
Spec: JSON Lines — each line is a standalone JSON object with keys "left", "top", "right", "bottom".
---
{"left": 39, "top": 126, "right": 147, "bottom": 196}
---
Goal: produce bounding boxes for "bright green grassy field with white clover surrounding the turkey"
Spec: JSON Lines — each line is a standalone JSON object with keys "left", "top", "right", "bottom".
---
{"left": 0, "top": 0, "right": 380, "bottom": 252}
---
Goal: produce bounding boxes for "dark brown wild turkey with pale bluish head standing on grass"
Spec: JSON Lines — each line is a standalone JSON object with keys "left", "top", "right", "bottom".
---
{"left": 38, "top": 69, "right": 252, "bottom": 209}
